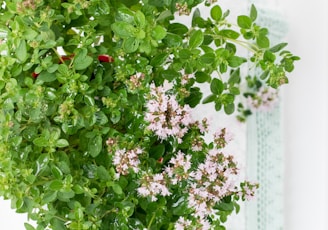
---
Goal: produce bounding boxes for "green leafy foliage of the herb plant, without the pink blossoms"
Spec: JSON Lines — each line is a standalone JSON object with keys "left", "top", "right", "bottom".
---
{"left": 0, "top": 0, "right": 298, "bottom": 230}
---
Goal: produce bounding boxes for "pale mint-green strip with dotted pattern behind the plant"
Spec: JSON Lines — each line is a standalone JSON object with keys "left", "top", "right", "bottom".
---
{"left": 246, "top": 1, "right": 287, "bottom": 230}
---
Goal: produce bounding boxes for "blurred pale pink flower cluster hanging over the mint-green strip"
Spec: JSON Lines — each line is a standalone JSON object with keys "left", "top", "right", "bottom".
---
{"left": 247, "top": 87, "right": 278, "bottom": 111}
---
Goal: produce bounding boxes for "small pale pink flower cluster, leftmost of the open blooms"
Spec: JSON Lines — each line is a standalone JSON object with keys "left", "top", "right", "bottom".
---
{"left": 113, "top": 147, "right": 143, "bottom": 175}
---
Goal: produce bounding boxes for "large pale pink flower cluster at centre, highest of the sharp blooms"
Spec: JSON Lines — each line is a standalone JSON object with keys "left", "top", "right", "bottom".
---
{"left": 145, "top": 84, "right": 193, "bottom": 142}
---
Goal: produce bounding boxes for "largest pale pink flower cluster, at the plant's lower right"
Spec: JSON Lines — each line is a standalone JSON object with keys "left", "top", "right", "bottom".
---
{"left": 188, "top": 149, "right": 238, "bottom": 220}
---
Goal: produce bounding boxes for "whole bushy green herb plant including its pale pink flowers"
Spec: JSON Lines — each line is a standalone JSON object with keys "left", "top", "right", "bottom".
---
{"left": 0, "top": 0, "right": 299, "bottom": 230}
